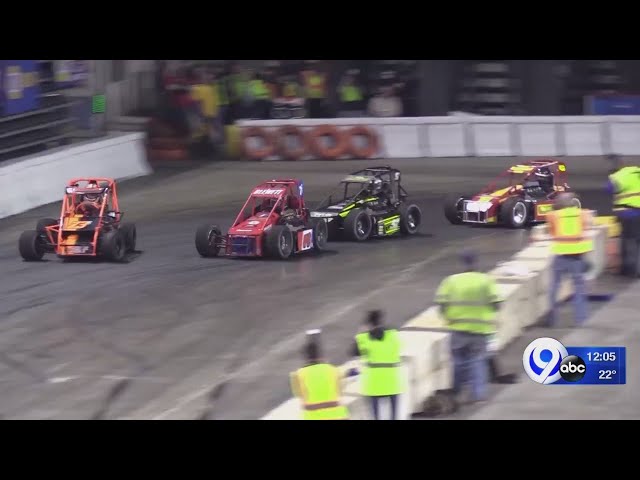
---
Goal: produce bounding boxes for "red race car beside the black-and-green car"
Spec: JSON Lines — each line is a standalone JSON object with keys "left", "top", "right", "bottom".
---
{"left": 195, "top": 179, "right": 328, "bottom": 259}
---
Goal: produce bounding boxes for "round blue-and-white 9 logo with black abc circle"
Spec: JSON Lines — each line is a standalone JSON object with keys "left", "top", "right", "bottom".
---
{"left": 522, "top": 337, "right": 587, "bottom": 385}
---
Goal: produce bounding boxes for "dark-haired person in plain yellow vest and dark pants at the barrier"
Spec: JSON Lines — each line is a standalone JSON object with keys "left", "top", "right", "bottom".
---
{"left": 353, "top": 310, "right": 404, "bottom": 420}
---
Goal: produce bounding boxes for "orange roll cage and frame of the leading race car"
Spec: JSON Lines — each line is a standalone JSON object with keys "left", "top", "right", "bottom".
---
{"left": 45, "top": 177, "right": 124, "bottom": 248}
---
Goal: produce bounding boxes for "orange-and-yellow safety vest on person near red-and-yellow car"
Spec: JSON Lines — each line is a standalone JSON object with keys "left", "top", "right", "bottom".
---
{"left": 547, "top": 207, "right": 593, "bottom": 255}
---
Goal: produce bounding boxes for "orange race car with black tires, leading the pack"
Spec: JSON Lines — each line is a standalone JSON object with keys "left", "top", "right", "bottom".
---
{"left": 18, "top": 178, "right": 136, "bottom": 262}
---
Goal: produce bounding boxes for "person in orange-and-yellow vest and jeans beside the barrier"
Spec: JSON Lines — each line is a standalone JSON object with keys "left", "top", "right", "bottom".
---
{"left": 546, "top": 192, "right": 593, "bottom": 326}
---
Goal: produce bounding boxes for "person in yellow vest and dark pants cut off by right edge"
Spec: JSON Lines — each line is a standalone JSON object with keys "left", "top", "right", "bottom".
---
{"left": 607, "top": 155, "right": 640, "bottom": 278}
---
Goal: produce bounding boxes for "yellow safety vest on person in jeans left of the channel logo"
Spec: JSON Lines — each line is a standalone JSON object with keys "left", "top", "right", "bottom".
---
{"left": 436, "top": 272, "right": 500, "bottom": 335}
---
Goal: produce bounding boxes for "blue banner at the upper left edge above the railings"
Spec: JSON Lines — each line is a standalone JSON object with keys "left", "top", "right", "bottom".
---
{"left": 0, "top": 60, "right": 40, "bottom": 116}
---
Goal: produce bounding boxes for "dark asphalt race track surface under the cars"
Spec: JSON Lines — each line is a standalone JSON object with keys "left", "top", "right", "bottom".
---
{"left": 0, "top": 157, "right": 608, "bottom": 419}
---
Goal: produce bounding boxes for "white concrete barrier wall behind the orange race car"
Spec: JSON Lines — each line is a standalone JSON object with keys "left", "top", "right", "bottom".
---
{"left": 0, "top": 133, "right": 152, "bottom": 218}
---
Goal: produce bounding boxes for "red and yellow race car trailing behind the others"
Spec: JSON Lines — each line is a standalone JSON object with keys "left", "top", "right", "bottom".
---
{"left": 444, "top": 160, "right": 580, "bottom": 228}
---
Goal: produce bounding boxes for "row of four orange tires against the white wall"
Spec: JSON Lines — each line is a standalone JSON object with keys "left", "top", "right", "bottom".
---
{"left": 238, "top": 124, "right": 381, "bottom": 161}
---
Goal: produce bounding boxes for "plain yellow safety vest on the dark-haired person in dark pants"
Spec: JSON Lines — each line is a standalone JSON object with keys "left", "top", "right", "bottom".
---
{"left": 356, "top": 329, "right": 403, "bottom": 397}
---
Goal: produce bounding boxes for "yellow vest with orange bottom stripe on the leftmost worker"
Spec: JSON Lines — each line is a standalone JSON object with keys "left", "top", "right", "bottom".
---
{"left": 293, "top": 363, "right": 349, "bottom": 420}
